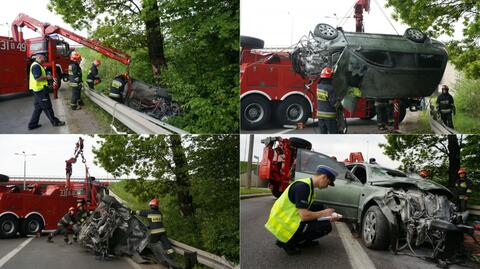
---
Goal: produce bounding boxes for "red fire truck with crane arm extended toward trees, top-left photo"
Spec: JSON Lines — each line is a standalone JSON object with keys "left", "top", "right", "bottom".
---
{"left": 0, "top": 14, "right": 130, "bottom": 98}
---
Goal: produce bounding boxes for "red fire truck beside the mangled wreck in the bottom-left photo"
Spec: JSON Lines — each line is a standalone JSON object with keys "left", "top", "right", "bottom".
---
{"left": 0, "top": 138, "right": 108, "bottom": 238}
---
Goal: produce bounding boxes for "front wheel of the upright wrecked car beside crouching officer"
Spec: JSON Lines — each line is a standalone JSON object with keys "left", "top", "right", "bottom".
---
{"left": 362, "top": 205, "right": 390, "bottom": 249}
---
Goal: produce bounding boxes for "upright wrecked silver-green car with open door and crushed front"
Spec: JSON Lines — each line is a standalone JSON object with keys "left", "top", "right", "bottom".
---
{"left": 295, "top": 149, "right": 473, "bottom": 263}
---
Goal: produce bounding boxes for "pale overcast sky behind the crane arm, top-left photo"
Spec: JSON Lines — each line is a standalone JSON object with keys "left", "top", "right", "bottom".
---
{"left": 0, "top": 0, "right": 88, "bottom": 40}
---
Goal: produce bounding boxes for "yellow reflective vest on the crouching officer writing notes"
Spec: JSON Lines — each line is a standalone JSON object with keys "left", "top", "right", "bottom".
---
{"left": 265, "top": 178, "right": 315, "bottom": 243}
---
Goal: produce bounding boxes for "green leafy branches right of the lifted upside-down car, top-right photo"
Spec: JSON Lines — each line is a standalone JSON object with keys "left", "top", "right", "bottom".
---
{"left": 387, "top": 0, "right": 480, "bottom": 78}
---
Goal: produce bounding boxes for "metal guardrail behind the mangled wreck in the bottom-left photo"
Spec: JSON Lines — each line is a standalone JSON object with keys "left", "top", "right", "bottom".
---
{"left": 109, "top": 190, "right": 240, "bottom": 269}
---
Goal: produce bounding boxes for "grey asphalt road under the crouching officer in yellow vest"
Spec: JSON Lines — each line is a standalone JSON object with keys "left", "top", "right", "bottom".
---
{"left": 240, "top": 196, "right": 473, "bottom": 269}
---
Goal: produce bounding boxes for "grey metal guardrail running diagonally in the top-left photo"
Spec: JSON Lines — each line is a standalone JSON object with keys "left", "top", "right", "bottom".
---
{"left": 84, "top": 86, "right": 188, "bottom": 134}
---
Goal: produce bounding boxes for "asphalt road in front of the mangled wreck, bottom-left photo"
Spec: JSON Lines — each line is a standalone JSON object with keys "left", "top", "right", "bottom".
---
{"left": 0, "top": 236, "right": 148, "bottom": 269}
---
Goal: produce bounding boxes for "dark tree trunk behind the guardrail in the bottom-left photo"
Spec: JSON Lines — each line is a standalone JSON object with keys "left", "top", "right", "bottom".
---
{"left": 170, "top": 135, "right": 195, "bottom": 217}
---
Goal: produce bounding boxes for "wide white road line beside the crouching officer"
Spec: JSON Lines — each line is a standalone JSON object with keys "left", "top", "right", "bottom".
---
{"left": 335, "top": 222, "right": 375, "bottom": 269}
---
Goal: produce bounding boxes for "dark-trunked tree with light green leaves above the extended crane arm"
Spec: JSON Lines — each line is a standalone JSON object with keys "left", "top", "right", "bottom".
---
{"left": 48, "top": 0, "right": 166, "bottom": 74}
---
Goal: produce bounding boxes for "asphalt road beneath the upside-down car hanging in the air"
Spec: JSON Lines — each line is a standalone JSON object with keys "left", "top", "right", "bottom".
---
{"left": 241, "top": 109, "right": 420, "bottom": 134}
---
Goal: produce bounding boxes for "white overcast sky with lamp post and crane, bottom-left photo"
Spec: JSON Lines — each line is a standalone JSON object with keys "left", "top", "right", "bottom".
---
{"left": 0, "top": 134, "right": 112, "bottom": 179}
